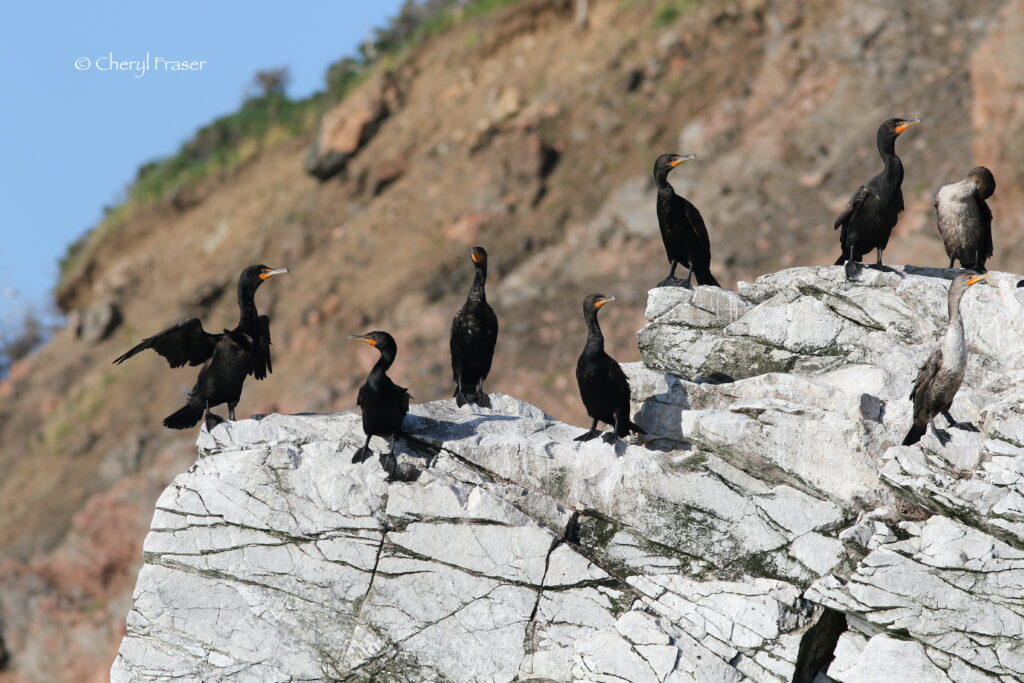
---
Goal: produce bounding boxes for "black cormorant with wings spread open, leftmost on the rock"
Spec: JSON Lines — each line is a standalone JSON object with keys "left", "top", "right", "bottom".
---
{"left": 114, "top": 265, "right": 288, "bottom": 429}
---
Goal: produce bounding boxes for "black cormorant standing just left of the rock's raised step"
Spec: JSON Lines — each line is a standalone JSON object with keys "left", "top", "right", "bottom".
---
{"left": 573, "top": 294, "right": 647, "bottom": 443}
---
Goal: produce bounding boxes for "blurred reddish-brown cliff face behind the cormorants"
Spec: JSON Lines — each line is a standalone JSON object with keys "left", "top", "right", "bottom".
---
{"left": 0, "top": 0, "right": 1024, "bottom": 681}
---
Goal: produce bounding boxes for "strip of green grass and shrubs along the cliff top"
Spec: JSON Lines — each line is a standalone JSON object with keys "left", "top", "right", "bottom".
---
{"left": 59, "top": 0, "right": 518, "bottom": 279}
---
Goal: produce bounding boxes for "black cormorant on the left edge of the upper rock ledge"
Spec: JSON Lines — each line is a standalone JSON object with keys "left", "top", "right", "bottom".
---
{"left": 654, "top": 155, "right": 719, "bottom": 287}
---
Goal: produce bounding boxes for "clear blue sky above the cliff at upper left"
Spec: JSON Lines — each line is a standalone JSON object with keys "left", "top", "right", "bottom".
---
{"left": 0, "top": 0, "right": 401, "bottom": 325}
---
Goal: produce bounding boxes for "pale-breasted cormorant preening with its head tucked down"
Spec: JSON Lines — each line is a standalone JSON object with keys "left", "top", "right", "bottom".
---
{"left": 935, "top": 166, "right": 995, "bottom": 272}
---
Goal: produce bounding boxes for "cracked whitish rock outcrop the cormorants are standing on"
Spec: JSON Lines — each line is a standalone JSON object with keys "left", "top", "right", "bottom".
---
{"left": 113, "top": 267, "right": 1024, "bottom": 683}
